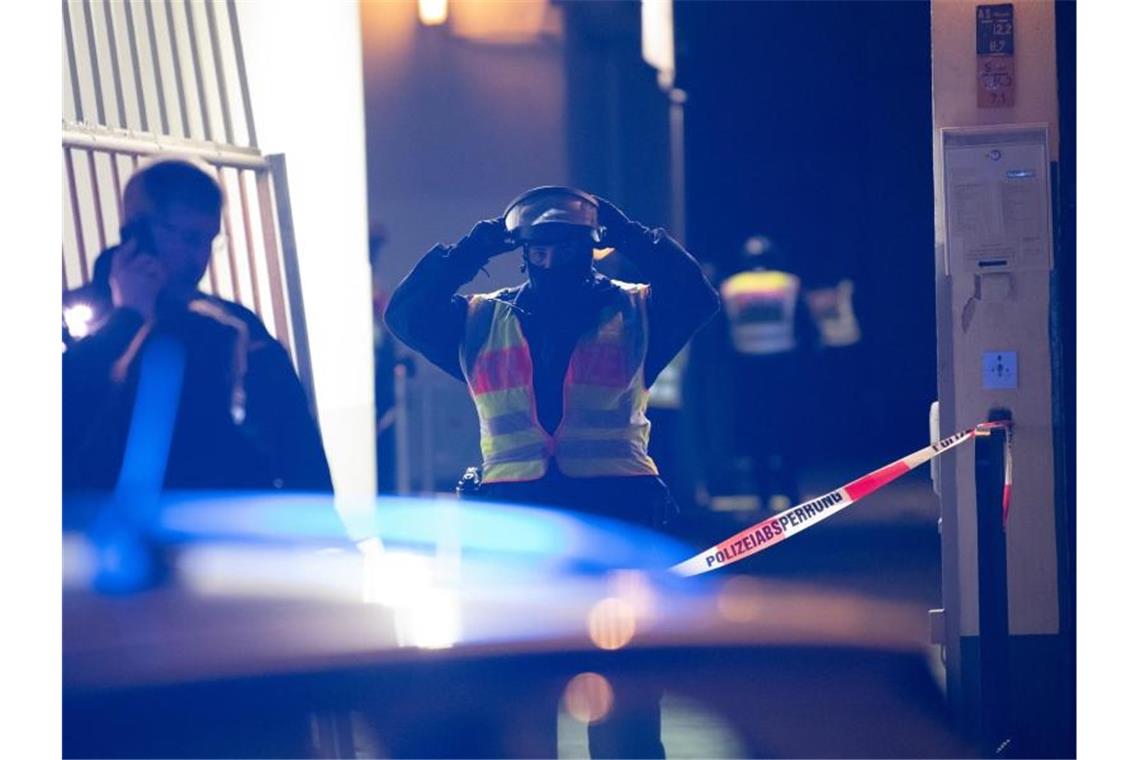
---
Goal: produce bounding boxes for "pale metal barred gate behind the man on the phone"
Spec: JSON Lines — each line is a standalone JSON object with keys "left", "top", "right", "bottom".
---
{"left": 62, "top": 0, "right": 314, "bottom": 400}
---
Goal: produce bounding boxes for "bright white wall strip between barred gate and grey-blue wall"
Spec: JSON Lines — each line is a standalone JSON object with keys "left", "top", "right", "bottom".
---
{"left": 237, "top": 0, "right": 376, "bottom": 496}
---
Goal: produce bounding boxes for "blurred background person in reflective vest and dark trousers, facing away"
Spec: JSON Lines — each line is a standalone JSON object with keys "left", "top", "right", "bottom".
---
{"left": 720, "top": 235, "right": 819, "bottom": 512}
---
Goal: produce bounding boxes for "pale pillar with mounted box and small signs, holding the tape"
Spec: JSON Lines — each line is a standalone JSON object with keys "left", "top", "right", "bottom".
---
{"left": 931, "top": 0, "right": 1075, "bottom": 757}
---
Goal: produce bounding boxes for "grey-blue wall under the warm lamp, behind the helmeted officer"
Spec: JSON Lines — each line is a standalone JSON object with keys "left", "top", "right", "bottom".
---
{"left": 360, "top": 0, "right": 568, "bottom": 300}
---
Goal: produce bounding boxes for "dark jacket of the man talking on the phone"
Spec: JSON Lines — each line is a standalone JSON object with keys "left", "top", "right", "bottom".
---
{"left": 63, "top": 299, "right": 333, "bottom": 492}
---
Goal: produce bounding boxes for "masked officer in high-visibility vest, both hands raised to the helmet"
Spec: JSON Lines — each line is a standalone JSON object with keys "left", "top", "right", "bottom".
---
{"left": 385, "top": 187, "right": 718, "bottom": 758}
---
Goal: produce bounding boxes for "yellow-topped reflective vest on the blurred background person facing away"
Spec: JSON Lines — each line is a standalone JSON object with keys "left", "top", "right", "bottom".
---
{"left": 720, "top": 271, "right": 799, "bottom": 354}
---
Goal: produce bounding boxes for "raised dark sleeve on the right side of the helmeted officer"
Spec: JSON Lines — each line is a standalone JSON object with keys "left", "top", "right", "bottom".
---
{"left": 619, "top": 228, "right": 720, "bottom": 385}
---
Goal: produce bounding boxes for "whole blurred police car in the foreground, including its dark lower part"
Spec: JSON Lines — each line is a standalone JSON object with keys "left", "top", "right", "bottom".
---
{"left": 63, "top": 495, "right": 957, "bottom": 757}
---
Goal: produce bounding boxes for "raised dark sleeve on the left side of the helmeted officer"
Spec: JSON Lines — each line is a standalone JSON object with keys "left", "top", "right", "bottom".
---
{"left": 384, "top": 242, "right": 488, "bottom": 381}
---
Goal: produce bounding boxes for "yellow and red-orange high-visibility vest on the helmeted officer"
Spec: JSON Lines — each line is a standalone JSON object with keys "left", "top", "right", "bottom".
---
{"left": 459, "top": 280, "right": 658, "bottom": 483}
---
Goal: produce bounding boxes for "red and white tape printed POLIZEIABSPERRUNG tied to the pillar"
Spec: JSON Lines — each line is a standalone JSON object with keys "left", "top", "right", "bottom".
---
{"left": 671, "top": 422, "right": 1013, "bottom": 575}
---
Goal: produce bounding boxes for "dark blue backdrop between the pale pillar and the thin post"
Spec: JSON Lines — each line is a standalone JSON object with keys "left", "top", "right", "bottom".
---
{"left": 676, "top": 2, "right": 936, "bottom": 457}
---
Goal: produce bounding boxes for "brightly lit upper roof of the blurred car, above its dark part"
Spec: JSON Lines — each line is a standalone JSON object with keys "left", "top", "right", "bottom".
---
{"left": 64, "top": 495, "right": 925, "bottom": 687}
